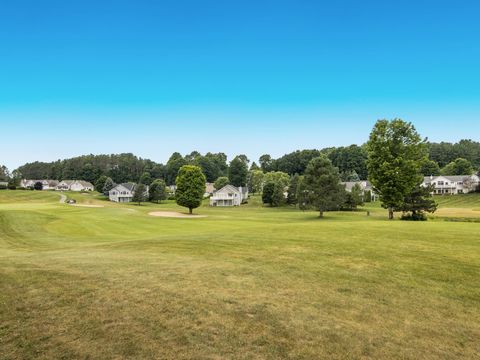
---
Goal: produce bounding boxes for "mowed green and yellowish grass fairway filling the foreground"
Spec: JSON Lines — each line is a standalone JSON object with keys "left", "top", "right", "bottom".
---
{"left": 0, "top": 191, "right": 480, "bottom": 359}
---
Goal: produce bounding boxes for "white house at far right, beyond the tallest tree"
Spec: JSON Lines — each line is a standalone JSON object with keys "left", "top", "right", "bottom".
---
{"left": 422, "top": 175, "right": 480, "bottom": 195}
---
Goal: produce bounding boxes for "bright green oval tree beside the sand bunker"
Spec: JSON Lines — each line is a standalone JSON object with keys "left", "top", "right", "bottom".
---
{"left": 175, "top": 165, "right": 206, "bottom": 214}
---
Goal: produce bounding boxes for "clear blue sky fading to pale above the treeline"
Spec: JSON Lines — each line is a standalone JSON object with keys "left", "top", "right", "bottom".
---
{"left": 0, "top": 0, "right": 480, "bottom": 169}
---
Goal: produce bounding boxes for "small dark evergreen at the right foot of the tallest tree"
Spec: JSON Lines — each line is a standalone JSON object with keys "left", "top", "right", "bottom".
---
{"left": 397, "top": 185, "right": 437, "bottom": 220}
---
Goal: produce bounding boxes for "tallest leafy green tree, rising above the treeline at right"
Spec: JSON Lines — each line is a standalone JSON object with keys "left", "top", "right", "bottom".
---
{"left": 367, "top": 119, "right": 427, "bottom": 219}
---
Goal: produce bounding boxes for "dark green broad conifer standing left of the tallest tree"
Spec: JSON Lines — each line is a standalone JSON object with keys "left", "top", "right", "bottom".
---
{"left": 302, "top": 155, "right": 345, "bottom": 217}
